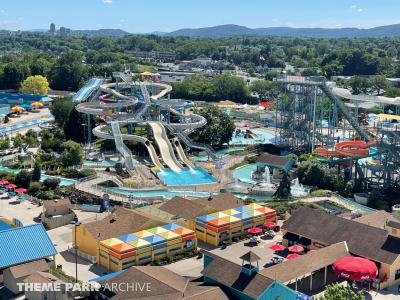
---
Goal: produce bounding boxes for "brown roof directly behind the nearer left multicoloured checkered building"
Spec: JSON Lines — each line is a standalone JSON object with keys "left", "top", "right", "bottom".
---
{"left": 84, "top": 207, "right": 166, "bottom": 240}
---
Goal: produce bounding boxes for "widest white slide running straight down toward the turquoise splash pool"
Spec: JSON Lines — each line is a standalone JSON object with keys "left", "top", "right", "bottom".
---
{"left": 148, "top": 122, "right": 183, "bottom": 172}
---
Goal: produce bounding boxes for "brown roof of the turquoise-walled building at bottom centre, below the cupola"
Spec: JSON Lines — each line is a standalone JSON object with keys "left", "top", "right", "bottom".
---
{"left": 201, "top": 252, "right": 274, "bottom": 298}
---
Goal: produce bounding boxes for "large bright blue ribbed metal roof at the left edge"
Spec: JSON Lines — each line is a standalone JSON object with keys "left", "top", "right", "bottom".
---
{"left": 0, "top": 224, "right": 57, "bottom": 269}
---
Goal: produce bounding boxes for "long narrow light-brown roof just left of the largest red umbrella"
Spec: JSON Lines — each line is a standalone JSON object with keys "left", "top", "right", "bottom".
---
{"left": 260, "top": 242, "right": 349, "bottom": 283}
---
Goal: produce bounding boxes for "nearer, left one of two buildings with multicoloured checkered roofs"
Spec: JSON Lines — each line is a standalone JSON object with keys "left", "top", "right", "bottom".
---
{"left": 97, "top": 223, "right": 197, "bottom": 271}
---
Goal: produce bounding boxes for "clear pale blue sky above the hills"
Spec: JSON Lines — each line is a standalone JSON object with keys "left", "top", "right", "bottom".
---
{"left": 0, "top": 0, "right": 400, "bottom": 33}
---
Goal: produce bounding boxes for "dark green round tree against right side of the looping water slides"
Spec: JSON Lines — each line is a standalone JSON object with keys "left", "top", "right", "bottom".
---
{"left": 193, "top": 106, "right": 235, "bottom": 145}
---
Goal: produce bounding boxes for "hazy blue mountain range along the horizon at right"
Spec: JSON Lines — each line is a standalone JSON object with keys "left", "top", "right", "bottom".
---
{"left": 161, "top": 24, "right": 400, "bottom": 38}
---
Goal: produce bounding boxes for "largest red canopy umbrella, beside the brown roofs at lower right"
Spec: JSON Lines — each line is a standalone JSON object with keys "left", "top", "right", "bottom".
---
{"left": 332, "top": 256, "right": 378, "bottom": 280}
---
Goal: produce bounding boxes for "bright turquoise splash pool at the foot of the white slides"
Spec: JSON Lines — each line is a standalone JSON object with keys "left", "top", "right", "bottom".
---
{"left": 157, "top": 167, "right": 217, "bottom": 186}
